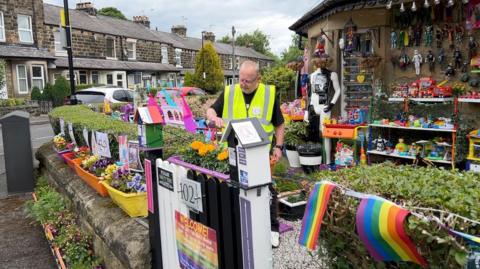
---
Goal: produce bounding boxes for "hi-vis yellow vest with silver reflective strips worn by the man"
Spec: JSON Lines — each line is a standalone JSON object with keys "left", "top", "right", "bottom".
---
{"left": 222, "top": 83, "right": 275, "bottom": 142}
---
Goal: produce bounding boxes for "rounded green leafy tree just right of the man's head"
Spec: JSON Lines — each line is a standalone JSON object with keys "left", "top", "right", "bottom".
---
{"left": 262, "top": 65, "right": 295, "bottom": 102}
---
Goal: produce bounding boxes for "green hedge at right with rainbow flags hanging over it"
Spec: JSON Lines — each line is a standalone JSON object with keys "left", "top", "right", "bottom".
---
{"left": 313, "top": 163, "right": 480, "bottom": 268}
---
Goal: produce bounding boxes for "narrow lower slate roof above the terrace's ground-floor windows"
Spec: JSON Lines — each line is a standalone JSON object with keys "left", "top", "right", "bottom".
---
{"left": 55, "top": 57, "right": 180, "bottom": 72}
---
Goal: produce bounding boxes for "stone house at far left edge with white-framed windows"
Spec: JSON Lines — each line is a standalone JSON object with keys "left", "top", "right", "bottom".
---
{"left": 0, "top": 0, "right": 54, "bottom": 99}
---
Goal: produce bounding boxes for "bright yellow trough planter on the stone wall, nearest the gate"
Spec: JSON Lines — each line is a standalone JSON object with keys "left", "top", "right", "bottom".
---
{"left": 100, "top": 181, "right": 148, "bottom": 218}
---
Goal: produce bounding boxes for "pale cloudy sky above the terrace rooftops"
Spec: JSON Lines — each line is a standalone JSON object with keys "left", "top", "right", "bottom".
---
{"left": 44, "top": 0, "right": 322, "bottom": 55}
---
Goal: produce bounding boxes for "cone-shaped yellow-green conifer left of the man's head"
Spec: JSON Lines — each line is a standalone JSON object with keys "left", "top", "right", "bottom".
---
{"left": 192, "top": 41, "right": 223, "bottom": 94}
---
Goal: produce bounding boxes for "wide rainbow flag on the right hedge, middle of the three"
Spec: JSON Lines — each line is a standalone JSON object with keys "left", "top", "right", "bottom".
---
{"left": 356, "top": 196, "right": 427, "bottom": 267}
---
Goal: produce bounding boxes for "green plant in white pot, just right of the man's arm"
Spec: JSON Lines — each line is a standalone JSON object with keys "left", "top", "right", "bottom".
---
{"left": 284, "top": 121, "right": 308, "bottom": 167}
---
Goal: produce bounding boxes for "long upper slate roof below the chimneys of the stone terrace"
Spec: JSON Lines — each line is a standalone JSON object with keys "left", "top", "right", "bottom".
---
{"left": 43, "top": 3, "right": 273, "bottom": 61}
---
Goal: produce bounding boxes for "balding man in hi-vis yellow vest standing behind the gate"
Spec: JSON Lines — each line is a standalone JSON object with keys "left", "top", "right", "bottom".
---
{"left": 207, "top": 60, "right": 285, "bottom": 247}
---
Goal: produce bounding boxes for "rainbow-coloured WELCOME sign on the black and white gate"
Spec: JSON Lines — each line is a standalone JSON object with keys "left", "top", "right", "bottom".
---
{"left": 175, "top": 211, "right": 218, "bottom": 269}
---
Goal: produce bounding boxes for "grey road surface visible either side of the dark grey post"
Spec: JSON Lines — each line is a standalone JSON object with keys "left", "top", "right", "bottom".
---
{"left": 0, "top": 123, "right": 53, "bottom": 199}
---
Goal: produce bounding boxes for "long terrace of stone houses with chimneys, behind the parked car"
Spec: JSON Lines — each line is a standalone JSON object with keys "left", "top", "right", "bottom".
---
{"left": 43, "top": 2, "right": 272, "bottom": 87}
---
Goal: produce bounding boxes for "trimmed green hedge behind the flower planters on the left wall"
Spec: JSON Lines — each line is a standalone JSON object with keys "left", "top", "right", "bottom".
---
{"left": 49, "top": 105, "right": 199, "bottom": 159}
